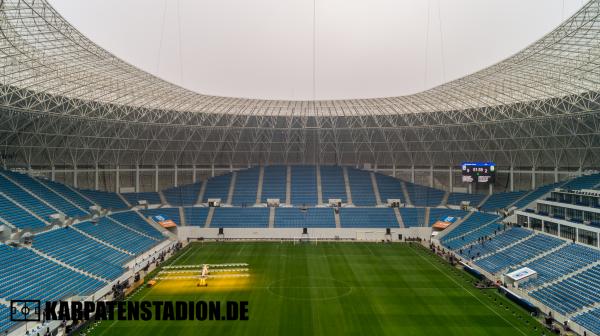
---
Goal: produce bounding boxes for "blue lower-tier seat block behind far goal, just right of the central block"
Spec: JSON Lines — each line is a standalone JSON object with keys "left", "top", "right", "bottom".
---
{"left": 340, "top": 208, "right": 399, "bottom": 228}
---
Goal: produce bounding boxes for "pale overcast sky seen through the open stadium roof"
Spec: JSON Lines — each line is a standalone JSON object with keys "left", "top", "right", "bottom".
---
{"left": 50, "top": 0, "right": 584, "bottom": 100}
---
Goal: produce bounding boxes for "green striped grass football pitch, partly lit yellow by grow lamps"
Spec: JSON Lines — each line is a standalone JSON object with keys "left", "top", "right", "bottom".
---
{"left": 87, "top": 242, "right": 542, "bottom": 336}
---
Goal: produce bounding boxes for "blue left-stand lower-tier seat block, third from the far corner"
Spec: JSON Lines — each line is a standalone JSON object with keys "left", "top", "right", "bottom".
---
{"left": 33, "top": 226, "right": 132, "bottom": 280}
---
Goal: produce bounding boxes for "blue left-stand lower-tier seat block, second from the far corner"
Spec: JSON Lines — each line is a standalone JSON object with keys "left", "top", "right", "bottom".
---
{"left": 75, "top": 217, "right": 158, "bottom": 255}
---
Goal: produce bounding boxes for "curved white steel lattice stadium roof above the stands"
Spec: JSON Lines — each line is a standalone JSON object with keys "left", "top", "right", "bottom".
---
{"left": 0, "top": 0, "right": 600, "bottom": 167}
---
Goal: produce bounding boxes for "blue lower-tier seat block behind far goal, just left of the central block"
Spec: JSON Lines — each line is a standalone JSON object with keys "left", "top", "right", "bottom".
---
{"left": 210, "top": 208, "right": 269, "bottom": 228}
